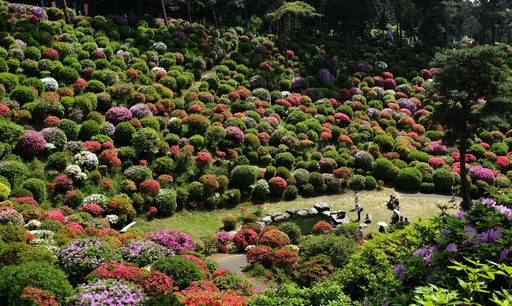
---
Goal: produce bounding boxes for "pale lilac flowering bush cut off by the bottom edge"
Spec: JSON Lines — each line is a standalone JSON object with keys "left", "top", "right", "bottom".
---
{"left": 68, "top": 279, "right": 146, "bottom": 306}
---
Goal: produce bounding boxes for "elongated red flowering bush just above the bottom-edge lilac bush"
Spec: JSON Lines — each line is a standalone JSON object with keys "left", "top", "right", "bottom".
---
{"left": 87, "top": 263, "right": 175, "bottom": 295}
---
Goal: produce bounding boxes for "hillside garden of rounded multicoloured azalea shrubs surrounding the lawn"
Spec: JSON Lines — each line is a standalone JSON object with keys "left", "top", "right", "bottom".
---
{"left": 0, "top": 1, "right": 512, "bottom": 306}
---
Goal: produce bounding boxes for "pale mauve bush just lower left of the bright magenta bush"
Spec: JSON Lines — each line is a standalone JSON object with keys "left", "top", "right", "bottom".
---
{"left": 121, "top": 239, "right": 174, "bottom": 267}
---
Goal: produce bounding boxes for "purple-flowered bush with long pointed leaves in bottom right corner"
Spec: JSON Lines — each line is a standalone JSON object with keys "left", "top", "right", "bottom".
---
{"left": 375, "top": 198, "right": 512, "bottom": 305}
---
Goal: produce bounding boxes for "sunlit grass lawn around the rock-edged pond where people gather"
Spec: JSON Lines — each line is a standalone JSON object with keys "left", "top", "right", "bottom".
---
{"left": 135, "top": 188, "right": 457, "bottom": 241}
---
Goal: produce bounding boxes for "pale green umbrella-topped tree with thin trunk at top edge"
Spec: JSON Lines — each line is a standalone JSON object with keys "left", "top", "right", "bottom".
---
{"left": 266, "top": 1, "right": 320, "bottom": 68}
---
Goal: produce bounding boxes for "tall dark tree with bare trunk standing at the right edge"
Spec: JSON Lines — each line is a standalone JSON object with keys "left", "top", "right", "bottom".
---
{"left": 433, "top": 46, "right": 512, "bottom": 210}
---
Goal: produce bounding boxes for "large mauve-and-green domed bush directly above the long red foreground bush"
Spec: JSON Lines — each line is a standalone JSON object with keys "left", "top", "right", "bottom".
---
{"left": 57, "top": 238, "right": 122, "bottom": 284}
